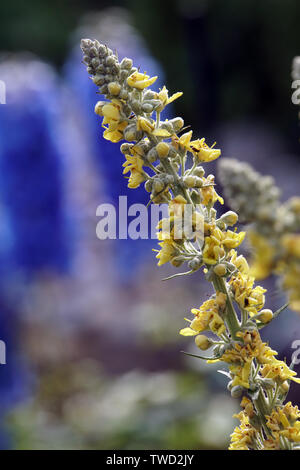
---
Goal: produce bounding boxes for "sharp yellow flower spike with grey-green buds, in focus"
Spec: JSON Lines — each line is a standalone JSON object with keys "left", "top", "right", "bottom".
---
{"left": 81, "top": 39, "right": 299, "bottom": 449}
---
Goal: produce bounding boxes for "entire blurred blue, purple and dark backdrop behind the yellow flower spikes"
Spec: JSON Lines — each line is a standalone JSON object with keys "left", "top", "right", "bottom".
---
{"left": 0, "top": 0, "right": 300, "bottom": 449}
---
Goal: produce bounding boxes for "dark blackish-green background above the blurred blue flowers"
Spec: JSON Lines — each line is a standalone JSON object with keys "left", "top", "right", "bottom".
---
{"left": 0, "top": 0, "right": 300, "bottom": 140}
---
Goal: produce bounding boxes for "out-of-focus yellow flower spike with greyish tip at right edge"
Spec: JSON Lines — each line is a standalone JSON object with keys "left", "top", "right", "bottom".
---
{"left": 219, "top": 159, "right": 300, "bottom": 312}
